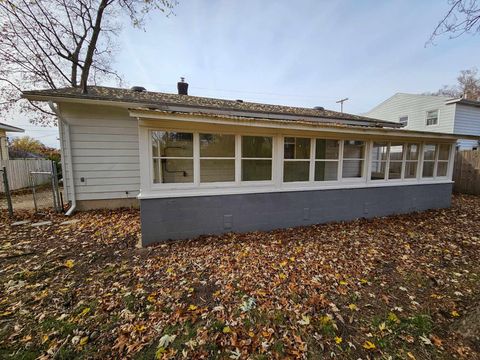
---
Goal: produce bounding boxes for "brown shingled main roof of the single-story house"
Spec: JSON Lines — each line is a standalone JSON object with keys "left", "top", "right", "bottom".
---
{"left": 23, "top": 86, "right": 401, "bottom": 127}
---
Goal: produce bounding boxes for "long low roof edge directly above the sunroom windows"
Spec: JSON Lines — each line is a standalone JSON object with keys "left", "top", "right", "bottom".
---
{"left": 129, "top": 108, "right": 480, "bottom": 142}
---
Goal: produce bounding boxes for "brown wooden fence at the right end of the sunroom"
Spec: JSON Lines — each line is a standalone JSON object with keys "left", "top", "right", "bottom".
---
{"left": 453, "top": 150, "right": 480, "bottom": 195}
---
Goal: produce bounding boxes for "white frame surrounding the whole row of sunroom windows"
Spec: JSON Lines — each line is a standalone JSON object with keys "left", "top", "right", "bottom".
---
{"left": 139, "top": 126, "right": 455, "bottom": 198}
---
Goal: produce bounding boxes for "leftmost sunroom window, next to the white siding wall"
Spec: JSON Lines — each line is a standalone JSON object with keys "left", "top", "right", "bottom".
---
{"left": 152, "top": 131, "right": 193, "bottom": 184}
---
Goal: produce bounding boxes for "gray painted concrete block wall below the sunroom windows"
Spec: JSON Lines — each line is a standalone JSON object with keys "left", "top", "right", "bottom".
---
{"left": 140, "top": 184, "right": 452, "bottom": 246}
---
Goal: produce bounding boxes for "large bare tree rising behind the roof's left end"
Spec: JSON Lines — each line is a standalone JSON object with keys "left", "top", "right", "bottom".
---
{"left": 0, "top": 0, "right": 177, "bottom": 124}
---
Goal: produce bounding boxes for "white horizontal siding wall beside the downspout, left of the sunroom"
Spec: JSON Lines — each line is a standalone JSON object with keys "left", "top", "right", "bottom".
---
{"left": 60, "top": 103, "right": 140, "bottom": 200}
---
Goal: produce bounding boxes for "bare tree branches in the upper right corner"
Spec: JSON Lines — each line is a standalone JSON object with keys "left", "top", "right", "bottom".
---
{"left": 427, "top": 0, "right": 480, "bottom": 43}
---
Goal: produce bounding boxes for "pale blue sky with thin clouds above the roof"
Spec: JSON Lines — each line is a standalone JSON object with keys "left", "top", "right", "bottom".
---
{"left": 4, "top": 0, "right": 480, "bottom": 146}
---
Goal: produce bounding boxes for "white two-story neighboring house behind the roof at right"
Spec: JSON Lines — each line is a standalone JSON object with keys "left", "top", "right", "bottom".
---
{"left": 364, "top": 93, "right": 480, "bottom": 149}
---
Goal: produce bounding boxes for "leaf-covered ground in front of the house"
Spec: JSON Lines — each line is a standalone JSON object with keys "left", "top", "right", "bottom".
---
{"left": 0, "top": 196, "right": 480, "bottom": 359}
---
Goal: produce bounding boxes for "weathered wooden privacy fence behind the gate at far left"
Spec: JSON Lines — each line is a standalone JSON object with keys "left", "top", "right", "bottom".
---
{"left": 0, "top": 159, "right": 52, "bottom": 193}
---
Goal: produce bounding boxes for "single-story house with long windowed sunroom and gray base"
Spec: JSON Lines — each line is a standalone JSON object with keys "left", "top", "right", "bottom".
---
{"left": 23, "top": 81, "right": 479, "bottom": 245}
